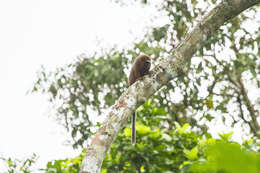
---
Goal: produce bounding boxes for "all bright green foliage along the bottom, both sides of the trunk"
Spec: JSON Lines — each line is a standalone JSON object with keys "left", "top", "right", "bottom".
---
{"left": 39, "top": 123, "right": 260, "bottom": 173}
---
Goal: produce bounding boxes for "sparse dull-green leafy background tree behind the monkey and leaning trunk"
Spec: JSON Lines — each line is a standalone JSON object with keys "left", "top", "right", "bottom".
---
{"left": 33, "top": 0, "right": 260, "bottom": 172}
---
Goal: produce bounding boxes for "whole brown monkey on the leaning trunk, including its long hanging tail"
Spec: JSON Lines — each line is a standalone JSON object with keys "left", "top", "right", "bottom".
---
{"left": 128, "top": 54, "right": 151, "bottom": 145}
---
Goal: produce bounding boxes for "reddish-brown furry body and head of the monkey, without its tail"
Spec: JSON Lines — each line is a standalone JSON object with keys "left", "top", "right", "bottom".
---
{"left": 128, "top": 54, "right": 151, "bottom": 85}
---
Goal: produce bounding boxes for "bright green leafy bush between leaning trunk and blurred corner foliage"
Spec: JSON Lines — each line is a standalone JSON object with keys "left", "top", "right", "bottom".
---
{"left": 102, "top": 119, "right": 201, "bottom": 173}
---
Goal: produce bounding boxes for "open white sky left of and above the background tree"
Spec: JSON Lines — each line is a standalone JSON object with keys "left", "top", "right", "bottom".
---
{"left": 0, "top": 0, "right": 157, "bottom": 172}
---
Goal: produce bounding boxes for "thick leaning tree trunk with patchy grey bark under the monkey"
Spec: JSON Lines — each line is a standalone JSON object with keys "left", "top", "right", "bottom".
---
{"left": 80, "top": 0, "right": 260, "bottom": 173}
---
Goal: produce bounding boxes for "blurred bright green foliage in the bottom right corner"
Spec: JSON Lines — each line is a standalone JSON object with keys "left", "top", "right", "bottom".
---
{"left": 191, "top": 141, "right": 260, "bottom": 173}
